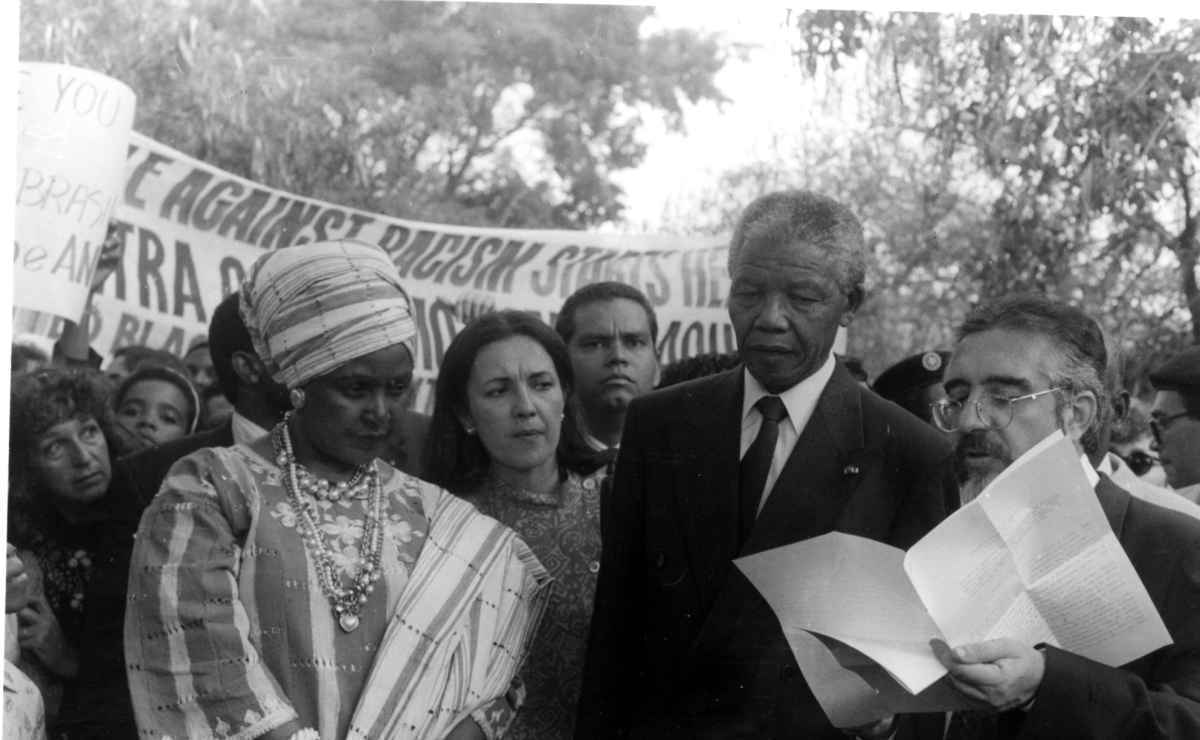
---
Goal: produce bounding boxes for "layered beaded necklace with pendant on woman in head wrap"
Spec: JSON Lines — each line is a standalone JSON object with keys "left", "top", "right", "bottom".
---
{"left": 271, "top": 413, "right": 385, "bottom": 632}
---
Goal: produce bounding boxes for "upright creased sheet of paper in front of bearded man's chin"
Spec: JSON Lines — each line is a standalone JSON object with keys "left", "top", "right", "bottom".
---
{"left": 905, "top": 432, "right": 1171, "bottom": 666}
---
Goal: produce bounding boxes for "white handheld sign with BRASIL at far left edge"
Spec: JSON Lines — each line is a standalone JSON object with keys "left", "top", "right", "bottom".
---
{"left": 13, "top": 62, "right": 137, "bottom": 331}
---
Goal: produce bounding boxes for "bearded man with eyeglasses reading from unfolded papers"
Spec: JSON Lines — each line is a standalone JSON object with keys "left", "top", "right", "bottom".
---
{"left": 917, "top": 296, "right": 1200, "bottom": 740}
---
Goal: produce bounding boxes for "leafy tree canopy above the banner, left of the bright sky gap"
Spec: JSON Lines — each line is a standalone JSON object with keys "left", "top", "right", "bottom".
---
{"left": 20, "top": 0, "right": 725, "bottom": 228}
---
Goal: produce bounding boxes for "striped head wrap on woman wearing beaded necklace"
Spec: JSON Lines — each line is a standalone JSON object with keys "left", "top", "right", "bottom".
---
{"left": 239, "top": 240, "right": 416, "bottom": 389}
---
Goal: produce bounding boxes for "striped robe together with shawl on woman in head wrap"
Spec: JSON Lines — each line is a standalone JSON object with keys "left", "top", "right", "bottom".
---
{"left": 125, "top": 446, "right": 546, "bottom": 739}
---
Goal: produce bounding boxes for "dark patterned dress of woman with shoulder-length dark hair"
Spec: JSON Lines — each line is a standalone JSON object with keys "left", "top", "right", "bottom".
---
{"left": 463, "top": 468, "right": 605, "bottom": 740}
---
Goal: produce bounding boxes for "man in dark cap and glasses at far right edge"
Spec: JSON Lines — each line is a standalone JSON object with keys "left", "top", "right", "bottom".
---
{"left": 1150, "top": 345, "right": 1200, "bottom": 504}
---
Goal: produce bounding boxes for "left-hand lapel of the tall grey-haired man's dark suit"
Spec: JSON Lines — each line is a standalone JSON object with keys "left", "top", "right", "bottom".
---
{"left": 673, "top": 366, "right": 743, "bottom": 604}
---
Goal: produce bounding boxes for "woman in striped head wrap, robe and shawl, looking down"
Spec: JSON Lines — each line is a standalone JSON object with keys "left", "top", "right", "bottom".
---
{"left": 125, "top": 241, "right": 548, "bottom": 740}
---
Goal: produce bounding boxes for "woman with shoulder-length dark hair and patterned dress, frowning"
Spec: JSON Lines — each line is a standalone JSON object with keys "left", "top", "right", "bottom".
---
{"left": 426, "top": 311, "right": 602, "bottom": 739}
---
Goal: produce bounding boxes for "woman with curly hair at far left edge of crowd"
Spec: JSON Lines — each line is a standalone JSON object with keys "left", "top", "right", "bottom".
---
{"left": 8, "top": 368, "right": 138, "bottom": 730}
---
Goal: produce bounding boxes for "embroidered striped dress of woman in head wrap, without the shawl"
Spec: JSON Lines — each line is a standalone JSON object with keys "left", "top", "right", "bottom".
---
{"left": 125, "top": 440, "right": 523, "bottom": 739}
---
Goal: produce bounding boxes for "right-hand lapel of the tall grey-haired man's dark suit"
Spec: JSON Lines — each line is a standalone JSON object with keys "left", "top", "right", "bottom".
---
{"left": 744, "top": 365, "right": 863, "bottom": 553}
